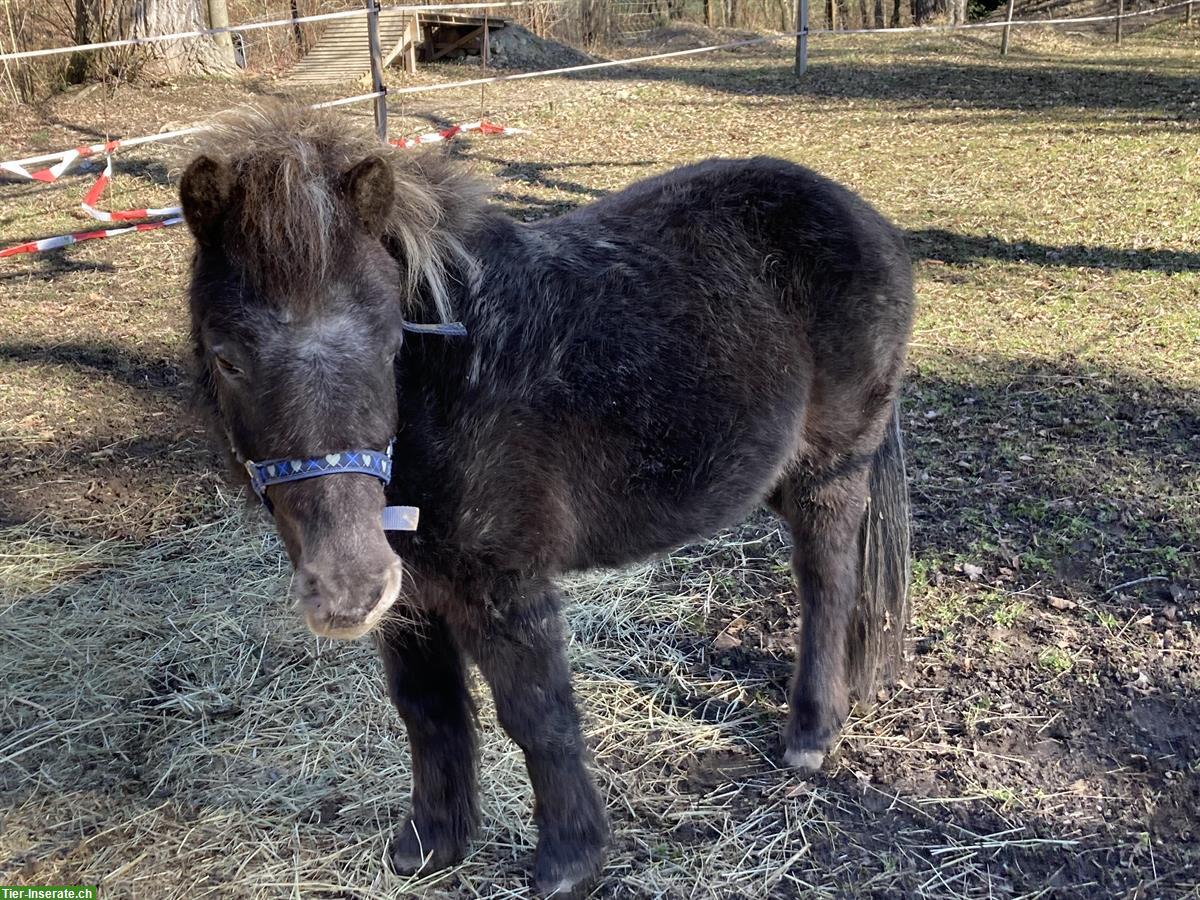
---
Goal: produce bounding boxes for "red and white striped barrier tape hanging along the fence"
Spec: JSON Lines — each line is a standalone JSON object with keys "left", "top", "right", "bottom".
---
{"left": 0, "top": 121, "right": 527, "bottom": 259}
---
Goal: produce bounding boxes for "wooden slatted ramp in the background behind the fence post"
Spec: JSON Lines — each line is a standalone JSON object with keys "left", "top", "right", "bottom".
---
{"left": 288, "top": 10, "right": 421, "bottom": 88}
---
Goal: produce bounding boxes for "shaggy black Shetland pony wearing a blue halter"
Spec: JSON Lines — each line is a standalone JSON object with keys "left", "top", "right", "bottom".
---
{"left": 181, "top": 107, "right": 913, "bottom": 895}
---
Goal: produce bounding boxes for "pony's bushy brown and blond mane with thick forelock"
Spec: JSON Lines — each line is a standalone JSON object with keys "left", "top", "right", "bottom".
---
{"left": 199, "top": 103, "right": 487, "bottom": 320}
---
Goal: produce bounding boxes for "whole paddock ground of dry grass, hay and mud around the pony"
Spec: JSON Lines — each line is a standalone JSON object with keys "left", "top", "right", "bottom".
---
{"left": 0, "top": 19, "right": 1200, "bottom": 900}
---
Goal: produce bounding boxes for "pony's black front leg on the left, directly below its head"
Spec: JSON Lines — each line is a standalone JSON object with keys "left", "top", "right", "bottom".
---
{"left": 376, "top": 614, "right": 479, "bottom": 875}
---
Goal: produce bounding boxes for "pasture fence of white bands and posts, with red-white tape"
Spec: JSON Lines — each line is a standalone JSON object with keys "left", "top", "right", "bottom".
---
{"left": 0, "top": 0, "right": 1195, "bottom": 258}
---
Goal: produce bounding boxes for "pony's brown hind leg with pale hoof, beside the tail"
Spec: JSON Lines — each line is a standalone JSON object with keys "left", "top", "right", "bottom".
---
{"left": 770, "top": 457, "right": 870, "bottom": 770}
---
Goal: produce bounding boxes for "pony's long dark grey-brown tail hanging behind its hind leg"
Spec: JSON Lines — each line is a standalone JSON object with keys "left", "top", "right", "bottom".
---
{"left": 846, "top": 406, "right": 911, "bottom": 707}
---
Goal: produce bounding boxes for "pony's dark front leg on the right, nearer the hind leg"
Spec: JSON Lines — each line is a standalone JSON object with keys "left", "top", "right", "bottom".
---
{"left": 472, "top": 582, "right": 608, "bottom": 898}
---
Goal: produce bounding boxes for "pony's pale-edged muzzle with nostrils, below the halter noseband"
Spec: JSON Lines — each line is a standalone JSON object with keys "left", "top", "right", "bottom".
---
{"left": 292, "top": 556, "right": 403, "bottom": 641}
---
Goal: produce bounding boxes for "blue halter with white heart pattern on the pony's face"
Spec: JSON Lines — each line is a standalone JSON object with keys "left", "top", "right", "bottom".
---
{"left": 239, "top": 322, "right": 467, "bottom": 532}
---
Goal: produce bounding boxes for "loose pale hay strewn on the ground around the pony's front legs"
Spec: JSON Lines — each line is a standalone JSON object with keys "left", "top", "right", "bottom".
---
{"left": 0, "top": 515, "right": 1108, "bottom": 898}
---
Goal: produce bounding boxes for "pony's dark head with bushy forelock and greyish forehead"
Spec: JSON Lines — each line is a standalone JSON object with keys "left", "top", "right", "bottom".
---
{"left": 180, "top": 106, "right": 478, "bottom": 637}
